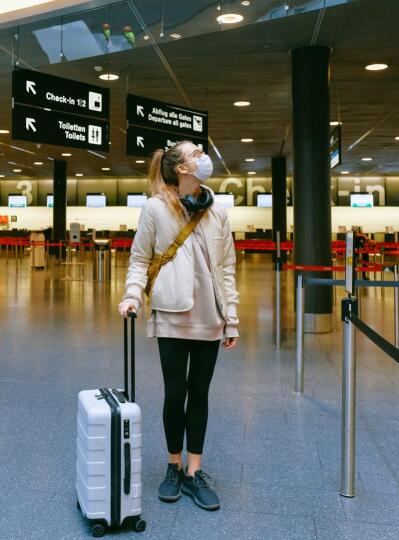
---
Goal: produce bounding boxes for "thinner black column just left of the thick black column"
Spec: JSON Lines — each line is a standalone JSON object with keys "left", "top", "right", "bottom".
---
{"left": 272, "top": 156, "right": 287, "bottom": 262}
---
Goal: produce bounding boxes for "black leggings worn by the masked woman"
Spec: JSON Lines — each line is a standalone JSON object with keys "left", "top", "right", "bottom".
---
{"left": 158, "top": 338, "right": 220, "bottom": 454}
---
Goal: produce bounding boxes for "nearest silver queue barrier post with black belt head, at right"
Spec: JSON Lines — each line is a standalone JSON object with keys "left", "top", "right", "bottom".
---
{"left": 341, "top": 296, "right": 357, "bottom": 497}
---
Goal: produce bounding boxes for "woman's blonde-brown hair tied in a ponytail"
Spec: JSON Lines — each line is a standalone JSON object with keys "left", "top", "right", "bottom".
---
{"left": 148, "top": 141, "right": 188, "bottom": 215}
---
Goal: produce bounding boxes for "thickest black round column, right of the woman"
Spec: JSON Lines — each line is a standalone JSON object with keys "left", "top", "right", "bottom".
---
{"left": 291, "top": 46, "right": 332, "bottom": 332}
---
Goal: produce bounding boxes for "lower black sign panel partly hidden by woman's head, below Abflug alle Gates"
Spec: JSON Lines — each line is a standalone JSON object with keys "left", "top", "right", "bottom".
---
{"left": 127, "top": 126, "right": 208, "bottom": 156}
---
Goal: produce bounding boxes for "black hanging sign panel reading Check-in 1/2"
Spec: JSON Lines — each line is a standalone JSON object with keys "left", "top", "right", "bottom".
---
{"left": 12, "top": 69, "right": 109, "bottom": 120}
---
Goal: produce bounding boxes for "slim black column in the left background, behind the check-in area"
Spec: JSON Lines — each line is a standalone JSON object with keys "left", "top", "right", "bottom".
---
{"left": 53, "top": 159, "right": 67, "bottom": 255}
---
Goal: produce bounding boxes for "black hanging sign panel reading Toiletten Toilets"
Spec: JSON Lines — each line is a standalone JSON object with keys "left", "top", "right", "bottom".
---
{"left": 12, "top": 104, "right": 109, "bottom": 151}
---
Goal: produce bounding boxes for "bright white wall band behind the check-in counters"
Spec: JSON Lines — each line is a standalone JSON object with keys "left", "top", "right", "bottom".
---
{"left": 0, "top": 206, "right": 399, "bottom": 232}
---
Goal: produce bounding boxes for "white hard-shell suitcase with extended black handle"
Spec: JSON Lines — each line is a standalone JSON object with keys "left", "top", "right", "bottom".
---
{"left": 76, "top": 313, "right": 146, "bottom": 537}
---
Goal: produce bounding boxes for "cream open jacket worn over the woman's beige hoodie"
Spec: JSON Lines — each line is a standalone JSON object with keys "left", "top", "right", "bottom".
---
{"left": 124, "top": 190, "right": 239, "bottom": 324}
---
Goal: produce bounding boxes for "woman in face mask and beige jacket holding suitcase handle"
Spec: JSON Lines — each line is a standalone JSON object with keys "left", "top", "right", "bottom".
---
{"left": 119, "top": 141, "right": 238, "bottom": 510}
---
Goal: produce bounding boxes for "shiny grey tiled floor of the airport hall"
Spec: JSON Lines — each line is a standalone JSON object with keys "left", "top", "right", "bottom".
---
{"left": 0, "top": 255, "right": 399, "bottom": 540}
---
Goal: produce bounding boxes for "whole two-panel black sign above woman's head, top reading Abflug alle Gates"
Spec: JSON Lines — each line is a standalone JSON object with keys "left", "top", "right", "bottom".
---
{"left": 127, "top": 94, "right": 208, "bottom": 156}
